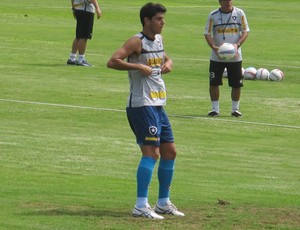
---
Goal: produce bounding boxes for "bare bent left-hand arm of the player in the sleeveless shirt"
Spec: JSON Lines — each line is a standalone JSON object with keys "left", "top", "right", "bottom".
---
{"left": 107, "top": 37, "right": 152, "bottom": 76}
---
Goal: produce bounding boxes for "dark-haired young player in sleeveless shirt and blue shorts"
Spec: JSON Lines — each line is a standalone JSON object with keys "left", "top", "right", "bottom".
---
{"left": 107, "top": 3, "right": 184, "bottom": 219}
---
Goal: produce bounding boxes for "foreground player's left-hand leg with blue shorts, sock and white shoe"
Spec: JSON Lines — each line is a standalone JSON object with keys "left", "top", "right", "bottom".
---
{"left": 126, "top": 107, "right": 163, "bottom": 219}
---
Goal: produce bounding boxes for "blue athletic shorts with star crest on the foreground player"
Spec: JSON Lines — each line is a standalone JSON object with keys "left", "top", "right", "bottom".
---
{"left": 126, "top": 106, "right": 174, "bottom": 146}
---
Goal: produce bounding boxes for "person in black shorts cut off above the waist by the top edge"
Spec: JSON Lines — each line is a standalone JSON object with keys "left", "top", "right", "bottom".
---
{"left": 67, "top": 0, "right": 102, "bottom": 66}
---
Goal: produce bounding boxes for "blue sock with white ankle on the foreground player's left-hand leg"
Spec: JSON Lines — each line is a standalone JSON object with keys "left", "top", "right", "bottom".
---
{"left": 136, "top": 156, "right": 156, "bottom": 208}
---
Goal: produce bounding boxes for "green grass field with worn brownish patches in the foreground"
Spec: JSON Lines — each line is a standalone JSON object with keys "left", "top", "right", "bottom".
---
{"left": 0, "top": 0, "right": 300, "bottom": 230}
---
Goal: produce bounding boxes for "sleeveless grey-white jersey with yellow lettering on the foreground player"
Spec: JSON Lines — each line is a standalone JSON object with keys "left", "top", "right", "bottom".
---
{"left": 127, "top": 33, "right": 167, "bottom": 107}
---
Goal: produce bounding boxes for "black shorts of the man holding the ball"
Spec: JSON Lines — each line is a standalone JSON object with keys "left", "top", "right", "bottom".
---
{"left": 209, "top": 60, "right": 243, "bottom": 88}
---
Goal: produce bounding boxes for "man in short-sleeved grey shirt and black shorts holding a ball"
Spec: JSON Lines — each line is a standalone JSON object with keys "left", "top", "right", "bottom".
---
{"left": 204, "top": 0, "right": 250, "bottom": 117}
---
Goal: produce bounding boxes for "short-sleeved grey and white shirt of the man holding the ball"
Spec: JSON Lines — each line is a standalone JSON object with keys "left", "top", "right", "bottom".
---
{"left": 204, "top": 7, "right": 250, "bottom": 62}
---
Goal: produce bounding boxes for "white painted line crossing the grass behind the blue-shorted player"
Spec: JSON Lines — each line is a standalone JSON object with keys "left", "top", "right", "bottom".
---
{"left": 0, "top": 98, "right": 300, "bottom": 129}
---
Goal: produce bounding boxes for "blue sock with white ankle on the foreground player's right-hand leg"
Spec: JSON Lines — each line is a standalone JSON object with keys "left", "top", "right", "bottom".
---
{"left": 157, "top": 159, "right": 175, "bottom": 206}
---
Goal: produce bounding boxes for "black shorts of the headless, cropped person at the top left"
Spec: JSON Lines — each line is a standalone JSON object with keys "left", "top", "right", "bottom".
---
{"left": 75, "top": 10, "right": 94, "bottom": 39}
